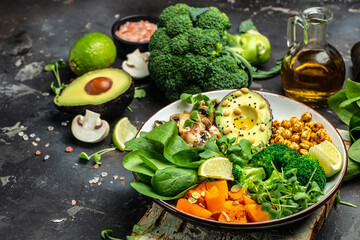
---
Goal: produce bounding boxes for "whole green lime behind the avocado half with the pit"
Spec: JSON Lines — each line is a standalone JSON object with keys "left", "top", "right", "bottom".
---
{"left": 69, "top": 32, "right": 116, "bottom": 75}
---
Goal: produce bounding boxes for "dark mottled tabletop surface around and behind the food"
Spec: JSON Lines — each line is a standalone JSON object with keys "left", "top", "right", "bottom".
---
{"left": 0, "top": 0, "right": 360, "bottom": 239}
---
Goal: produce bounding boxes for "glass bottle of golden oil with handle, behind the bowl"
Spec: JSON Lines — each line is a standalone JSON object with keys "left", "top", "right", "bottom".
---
{"left": 281, "top": 7, "right": 345, "bottom": 108}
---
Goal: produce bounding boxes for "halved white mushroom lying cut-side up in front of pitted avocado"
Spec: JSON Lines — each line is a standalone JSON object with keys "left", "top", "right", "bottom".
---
{"left": 71, "top": 110, "right": 110, "bottom": 143}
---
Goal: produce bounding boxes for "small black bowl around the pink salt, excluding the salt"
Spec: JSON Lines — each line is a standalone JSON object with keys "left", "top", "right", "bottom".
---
{"left": 111, "top": 15, "right": 158, "bottom": 59}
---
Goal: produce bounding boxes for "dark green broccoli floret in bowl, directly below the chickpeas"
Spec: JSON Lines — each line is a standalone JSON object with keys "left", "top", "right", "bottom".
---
{"left": 250, "top": 143, "right": 300, "bottom": 176}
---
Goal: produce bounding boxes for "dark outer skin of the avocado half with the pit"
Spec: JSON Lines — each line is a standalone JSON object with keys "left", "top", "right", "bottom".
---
{"left": 54, "top": 68, "right": 135, "bottom": 118}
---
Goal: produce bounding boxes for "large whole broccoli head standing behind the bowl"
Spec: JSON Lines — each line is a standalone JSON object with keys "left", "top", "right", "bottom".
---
{"left": 149, "top": 4, "right": 252, "bottom": 101}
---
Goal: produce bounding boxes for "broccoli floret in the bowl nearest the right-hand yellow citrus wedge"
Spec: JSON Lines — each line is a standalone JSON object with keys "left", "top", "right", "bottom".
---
{"left": 284, "top": 155, "right": 326, "bottom": 190}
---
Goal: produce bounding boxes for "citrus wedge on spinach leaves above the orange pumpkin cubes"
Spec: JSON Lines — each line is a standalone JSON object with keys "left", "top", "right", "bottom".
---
{"left": 198, "top": 157, "right": 234, "bottom": 180}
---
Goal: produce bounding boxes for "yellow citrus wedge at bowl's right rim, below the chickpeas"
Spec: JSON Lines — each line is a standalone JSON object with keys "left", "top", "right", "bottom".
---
{"left": 309, "top": 141, "right": 343, "bottom": 178}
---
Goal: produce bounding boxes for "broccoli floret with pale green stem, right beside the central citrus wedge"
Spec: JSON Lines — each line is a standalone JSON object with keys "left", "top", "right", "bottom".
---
{"left": 232, "top": 164, "right": 266, "bottom": 188}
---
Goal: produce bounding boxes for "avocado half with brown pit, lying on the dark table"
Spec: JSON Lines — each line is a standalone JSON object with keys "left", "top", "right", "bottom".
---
{"left": 54, "top": 68, "right": 134, "bottom": 117}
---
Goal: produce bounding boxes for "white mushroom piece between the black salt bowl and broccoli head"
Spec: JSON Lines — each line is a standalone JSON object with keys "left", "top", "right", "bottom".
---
{"left": 122, "top": 49, "right": 150, "bottom": 79}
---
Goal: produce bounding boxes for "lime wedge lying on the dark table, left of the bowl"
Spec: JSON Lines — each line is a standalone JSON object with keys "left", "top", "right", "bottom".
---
{"left": 113, "top": 117, "right": 137, "bottom": 151}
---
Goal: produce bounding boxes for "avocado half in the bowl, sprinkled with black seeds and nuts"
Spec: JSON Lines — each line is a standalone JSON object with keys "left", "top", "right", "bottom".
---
{"left": 216, "top": 88, "right": 272, "bottom": 146}
